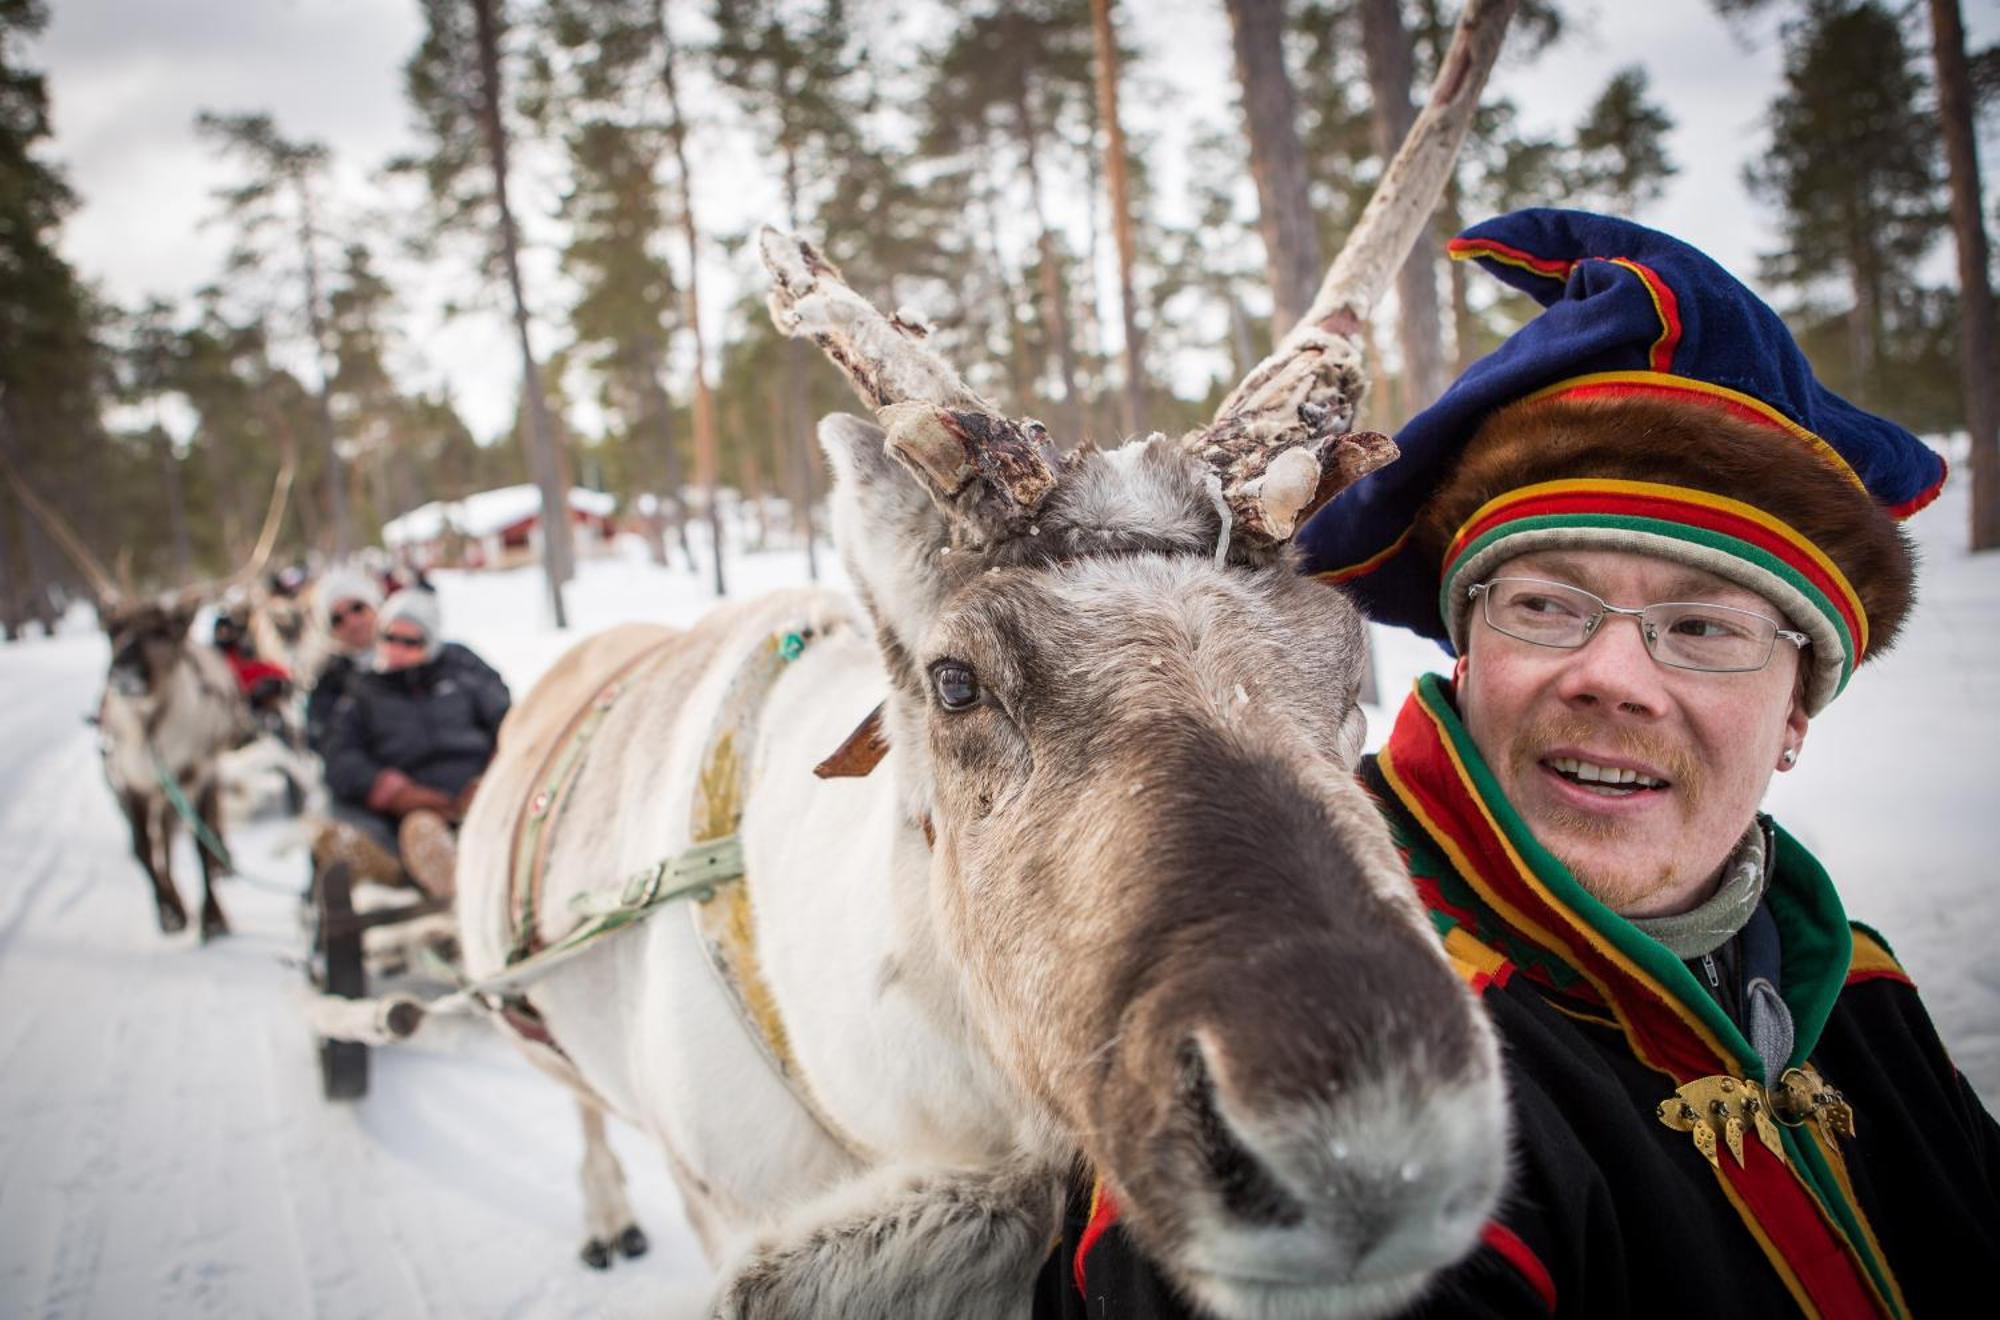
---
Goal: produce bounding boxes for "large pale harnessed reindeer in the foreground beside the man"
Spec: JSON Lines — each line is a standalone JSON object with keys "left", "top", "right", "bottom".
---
{"left": 458, "top": 0, "right": 1512, "bottom": 1318}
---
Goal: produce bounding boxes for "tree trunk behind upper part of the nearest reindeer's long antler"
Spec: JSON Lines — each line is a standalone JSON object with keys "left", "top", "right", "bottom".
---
{"left": 1360, "top": 0, "right": 1444, "bottom": 418}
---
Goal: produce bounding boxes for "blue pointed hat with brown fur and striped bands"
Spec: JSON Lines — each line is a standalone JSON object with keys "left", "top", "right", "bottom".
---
{"left": 1298, "top": 210, "right": 1944, "bottom": 712}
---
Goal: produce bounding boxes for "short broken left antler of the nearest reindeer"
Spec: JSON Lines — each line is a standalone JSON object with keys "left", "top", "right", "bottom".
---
{"left": 758, "top": 226, "right": 1058, "bottom": 530}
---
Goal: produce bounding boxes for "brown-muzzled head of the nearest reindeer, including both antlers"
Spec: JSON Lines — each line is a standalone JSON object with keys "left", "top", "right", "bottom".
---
{"left": 762, "top": 0, "right": 1512, "bottom": 1316}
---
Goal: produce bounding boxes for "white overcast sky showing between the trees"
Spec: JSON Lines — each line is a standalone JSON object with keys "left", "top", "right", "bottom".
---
{"left": 28, "top": 0, "right": 2000, "bottom": 438}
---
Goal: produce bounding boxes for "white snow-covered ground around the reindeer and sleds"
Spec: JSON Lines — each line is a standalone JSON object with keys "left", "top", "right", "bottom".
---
{"left": 11, "top": 470, "right": 2000, "bottom": 1318}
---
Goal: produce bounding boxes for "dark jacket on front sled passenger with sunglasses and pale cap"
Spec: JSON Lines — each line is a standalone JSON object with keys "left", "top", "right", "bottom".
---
{"left": 322, "top": 642, "right": 510, "bottom": 810}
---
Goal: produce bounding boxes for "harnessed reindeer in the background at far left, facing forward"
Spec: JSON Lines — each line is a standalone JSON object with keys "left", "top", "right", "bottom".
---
{"left": 4, "top": 454, "right": 294, "bottom": 944}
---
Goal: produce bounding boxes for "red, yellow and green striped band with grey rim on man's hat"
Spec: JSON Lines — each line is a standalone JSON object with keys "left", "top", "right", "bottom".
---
{"left": 1438, "top": 478, "right": 1868, "bottom": 714}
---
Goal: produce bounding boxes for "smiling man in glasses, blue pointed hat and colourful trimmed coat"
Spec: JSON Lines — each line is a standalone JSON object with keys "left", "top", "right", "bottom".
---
{"left": 1038, "top": 210, "right": 2000, "bottom": 1320}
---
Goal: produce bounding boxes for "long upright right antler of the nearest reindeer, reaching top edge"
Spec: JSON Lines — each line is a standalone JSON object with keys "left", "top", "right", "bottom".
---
{"left": 1186, "top": 0, "right": 1518, "bottom": 544}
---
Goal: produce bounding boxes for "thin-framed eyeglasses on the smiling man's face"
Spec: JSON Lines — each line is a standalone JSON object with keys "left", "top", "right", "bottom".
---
{"left": 1466, "top": 578, "right": 1812, "bottom": 674}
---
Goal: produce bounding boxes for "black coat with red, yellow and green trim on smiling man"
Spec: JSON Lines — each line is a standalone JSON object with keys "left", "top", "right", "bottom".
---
{"left": 1036, "top": 678, "right": 2000, "bottom": 1320}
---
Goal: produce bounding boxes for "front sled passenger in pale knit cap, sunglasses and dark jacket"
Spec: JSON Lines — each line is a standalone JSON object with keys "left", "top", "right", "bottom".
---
{"left": 324, "top": 588, "right": 510, "bottom": 898}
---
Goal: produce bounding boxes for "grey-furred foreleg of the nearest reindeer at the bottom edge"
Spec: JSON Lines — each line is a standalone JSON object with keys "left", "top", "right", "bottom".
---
{"left": 714, "top": 1158, "right": 1062, "bottom": 1320}
